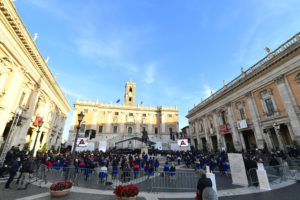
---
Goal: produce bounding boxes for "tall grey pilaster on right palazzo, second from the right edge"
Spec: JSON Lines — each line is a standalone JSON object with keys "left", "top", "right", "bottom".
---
{"left": 246, "top": 92, "right": 264, "bottom": 151}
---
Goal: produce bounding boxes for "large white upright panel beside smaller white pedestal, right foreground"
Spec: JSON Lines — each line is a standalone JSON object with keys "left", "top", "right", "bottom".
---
{"left": 228, "top": 153, "right": 248, "bottom": 186}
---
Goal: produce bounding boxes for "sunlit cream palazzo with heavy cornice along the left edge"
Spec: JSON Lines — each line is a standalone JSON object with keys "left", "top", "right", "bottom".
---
{"left": 0, "top": 0, "right": 71, "bottom": 156}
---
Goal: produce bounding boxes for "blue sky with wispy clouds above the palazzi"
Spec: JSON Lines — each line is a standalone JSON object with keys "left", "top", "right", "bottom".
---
{"left": 15, "top": 0, "right": 300, "bottom": 141}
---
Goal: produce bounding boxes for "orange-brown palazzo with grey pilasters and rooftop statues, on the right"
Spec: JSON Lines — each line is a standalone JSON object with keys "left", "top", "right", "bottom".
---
{"left": 186, "top": 33, "right": 300, "bottom": 151}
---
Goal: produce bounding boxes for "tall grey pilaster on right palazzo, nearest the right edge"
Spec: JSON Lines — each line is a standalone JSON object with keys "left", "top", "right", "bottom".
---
{"left": 275, "top": 75, "right": 300, "bottom": 141}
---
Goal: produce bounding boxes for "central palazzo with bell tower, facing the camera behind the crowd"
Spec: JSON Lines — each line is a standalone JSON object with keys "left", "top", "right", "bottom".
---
{"left": 68, "top": 81, "right": 179, "bottom": 149}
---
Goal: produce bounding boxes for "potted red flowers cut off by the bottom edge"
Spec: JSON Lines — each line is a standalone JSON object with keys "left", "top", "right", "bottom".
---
{"left": 114, "top": 184, "right": 140, "bottom": 200}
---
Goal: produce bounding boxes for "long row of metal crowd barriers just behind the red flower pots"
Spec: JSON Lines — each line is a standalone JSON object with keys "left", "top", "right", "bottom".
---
{"left": 35, "top": 165, "right": 200, "bottom": 192}
